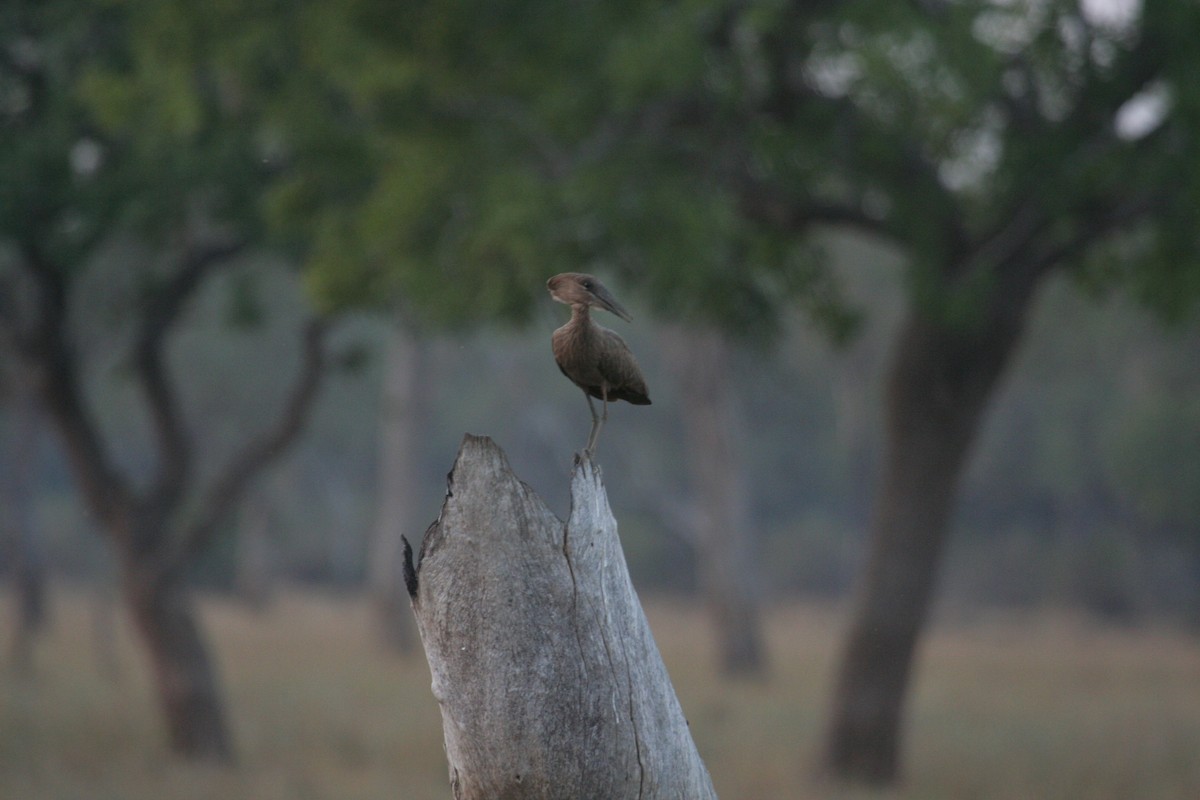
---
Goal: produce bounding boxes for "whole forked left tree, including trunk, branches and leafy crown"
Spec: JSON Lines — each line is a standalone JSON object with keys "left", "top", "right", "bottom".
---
{"left": 0, "top": 2, "right": 328, "bottom": 760}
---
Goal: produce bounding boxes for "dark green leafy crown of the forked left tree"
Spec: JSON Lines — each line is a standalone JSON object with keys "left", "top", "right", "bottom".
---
{"left": 0, "top": 1, "right": 263, "bottom": 270}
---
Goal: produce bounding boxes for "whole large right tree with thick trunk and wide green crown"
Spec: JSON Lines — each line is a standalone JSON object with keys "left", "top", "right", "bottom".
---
{"left": 309, "top": 1, "right": 1200, "bottom": 783}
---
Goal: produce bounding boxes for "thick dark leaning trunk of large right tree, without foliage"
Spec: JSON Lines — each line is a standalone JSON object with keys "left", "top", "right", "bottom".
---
{"left": 824, "top": 165, "right": 1157, "bottom": 784}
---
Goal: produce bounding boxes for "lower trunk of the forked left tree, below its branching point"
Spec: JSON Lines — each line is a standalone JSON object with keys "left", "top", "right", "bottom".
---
{"left": 124, "top": 557, "right": 233, "bottom": 763}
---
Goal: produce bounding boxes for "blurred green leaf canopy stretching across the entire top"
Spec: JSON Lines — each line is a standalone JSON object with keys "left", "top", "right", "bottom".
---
{"left": 9, "top": 0, "right": 1200, "bottom": 338}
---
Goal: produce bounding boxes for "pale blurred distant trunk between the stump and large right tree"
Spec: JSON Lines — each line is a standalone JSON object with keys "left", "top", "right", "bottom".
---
{"left": 664, "top": 327, "right": 767, "bottom": 675}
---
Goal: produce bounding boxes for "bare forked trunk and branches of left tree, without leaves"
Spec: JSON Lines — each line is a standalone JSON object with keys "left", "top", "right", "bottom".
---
{"left": 9, "top": 244, "right": 329, "bottom": 762}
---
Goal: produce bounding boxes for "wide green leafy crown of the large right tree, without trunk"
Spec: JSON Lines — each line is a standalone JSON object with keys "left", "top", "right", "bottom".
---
{"left": 292, "top": 0, "right": 1200, "bottom": 336}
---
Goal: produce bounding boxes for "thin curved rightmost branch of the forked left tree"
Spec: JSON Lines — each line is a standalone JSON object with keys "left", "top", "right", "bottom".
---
{"left": 162, "top": 319, "right": 329, "bottom": 582}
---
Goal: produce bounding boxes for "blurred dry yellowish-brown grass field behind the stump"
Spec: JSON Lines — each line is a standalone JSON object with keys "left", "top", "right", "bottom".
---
{"left": 0, "top": 593, "right": 1200, "bottom": 800}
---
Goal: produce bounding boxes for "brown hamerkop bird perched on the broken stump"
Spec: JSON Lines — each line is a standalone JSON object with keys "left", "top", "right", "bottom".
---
{"left": 546, "top": 272, "right": 650, "bottom": 455}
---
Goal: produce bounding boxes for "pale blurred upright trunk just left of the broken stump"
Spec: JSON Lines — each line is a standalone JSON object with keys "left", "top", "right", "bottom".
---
{"left": 368, "top": 326, "right": 425, "bottom": 654}
